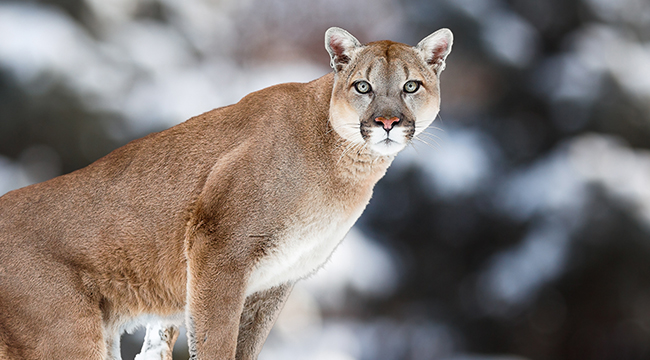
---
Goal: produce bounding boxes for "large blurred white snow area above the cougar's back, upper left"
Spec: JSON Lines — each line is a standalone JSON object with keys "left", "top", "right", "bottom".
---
{"left": 0, "top": 2, "right": 328, "bottom": 134}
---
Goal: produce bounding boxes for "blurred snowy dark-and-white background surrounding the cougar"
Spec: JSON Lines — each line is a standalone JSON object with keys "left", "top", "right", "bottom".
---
{"left": 0, "top": 0, "right": 650, "bottom": 360}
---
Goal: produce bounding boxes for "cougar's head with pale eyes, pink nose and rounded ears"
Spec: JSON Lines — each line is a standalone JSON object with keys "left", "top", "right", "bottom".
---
{"left": 325, "top": 27, "right": 453, "bottom": 156}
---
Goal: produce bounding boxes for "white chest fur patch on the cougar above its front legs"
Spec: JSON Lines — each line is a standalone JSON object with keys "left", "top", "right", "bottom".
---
{"left": 246, "top": 206, "right": 365, "bottom": 295}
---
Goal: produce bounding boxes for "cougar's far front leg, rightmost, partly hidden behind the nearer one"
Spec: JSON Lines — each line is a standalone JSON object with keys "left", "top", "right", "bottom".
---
{"left": 237, "top": 283, "right": 293, "bottom": 360}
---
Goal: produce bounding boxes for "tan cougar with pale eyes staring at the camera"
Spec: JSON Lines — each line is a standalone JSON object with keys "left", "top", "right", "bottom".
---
{"left": 0, "top": 27, "right": 452, "bottom": 360}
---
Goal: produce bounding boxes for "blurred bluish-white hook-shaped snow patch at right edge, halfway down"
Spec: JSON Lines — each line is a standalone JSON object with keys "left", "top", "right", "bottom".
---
{"left": 479, "top": 134, "right": 650, "bottom": 314}
